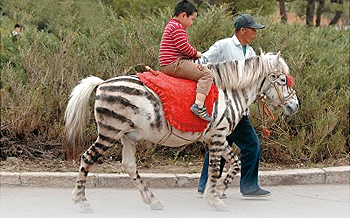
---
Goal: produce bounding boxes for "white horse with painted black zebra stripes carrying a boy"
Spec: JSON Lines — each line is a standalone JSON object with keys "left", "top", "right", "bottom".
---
{"left": 65, "top": 53, "right": 299, "bottom": 212}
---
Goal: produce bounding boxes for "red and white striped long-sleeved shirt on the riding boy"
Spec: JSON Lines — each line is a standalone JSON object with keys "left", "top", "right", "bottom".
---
{"left": 159, "top": 18, "right": 197, "bottom": 66}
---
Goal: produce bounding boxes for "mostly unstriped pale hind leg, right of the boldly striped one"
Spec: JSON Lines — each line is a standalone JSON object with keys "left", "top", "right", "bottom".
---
{"left": 122, "top": 136, "right": 164, "bottom": 210}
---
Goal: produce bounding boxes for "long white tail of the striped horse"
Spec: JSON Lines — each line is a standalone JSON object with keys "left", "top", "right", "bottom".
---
{"left": 64, "top": 76, "right": 104, "bottom": 145}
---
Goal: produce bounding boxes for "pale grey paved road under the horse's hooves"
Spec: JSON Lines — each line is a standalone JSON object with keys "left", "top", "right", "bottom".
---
{"left": 0, "top": 184, "right": 350, "bottom": 218}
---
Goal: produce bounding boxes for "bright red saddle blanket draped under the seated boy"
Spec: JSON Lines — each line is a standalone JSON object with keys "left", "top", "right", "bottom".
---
{"left": 137, "top": 72, "right": 217, "bottom": 132}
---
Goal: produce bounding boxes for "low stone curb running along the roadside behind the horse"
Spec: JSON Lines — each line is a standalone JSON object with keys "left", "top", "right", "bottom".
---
{"left": 0, "top": 166, "right": 350, "bottom": 188}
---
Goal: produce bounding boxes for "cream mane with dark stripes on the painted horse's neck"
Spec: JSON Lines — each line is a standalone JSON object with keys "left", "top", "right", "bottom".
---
{"left": 207, "top": 53, "right": 289, "bottom": 89}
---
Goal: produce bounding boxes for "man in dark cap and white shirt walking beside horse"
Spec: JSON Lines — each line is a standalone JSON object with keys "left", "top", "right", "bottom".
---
{"left": 198, "top": 14, "right": 270, "bottom": 197}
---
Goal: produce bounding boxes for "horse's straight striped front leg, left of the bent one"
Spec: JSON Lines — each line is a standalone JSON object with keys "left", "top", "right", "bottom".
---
{"left": 204, "top": 137, "right": 227, "bottom": 211}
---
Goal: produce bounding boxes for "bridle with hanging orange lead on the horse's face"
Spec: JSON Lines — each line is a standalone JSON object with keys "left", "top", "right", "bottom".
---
{"left": 258, "top": 71, "right": 295, "bottom": 137}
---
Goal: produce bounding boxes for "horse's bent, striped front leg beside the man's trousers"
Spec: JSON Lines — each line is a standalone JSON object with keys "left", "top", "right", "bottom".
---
{"left": 217, "top": 143, "right": 241, "bottom": 195}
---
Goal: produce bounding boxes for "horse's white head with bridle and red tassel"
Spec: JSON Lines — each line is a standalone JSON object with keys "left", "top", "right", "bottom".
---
{"left": 262, "top": 52, "right": 299, "bottom": 115}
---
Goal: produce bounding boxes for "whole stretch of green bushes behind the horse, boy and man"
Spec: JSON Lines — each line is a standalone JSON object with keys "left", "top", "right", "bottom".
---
{"left": 0, "top": 0, "right": 349, "bottom": 163}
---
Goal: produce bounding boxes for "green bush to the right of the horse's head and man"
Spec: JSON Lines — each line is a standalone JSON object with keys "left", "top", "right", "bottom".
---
{"left": 256, "top": 24, "right": 349, "bottom": 162}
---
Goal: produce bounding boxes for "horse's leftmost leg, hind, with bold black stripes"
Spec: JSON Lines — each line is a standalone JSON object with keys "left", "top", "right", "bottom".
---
{"left": 72, "top": 138, "right": 108, "bottom": 213}
